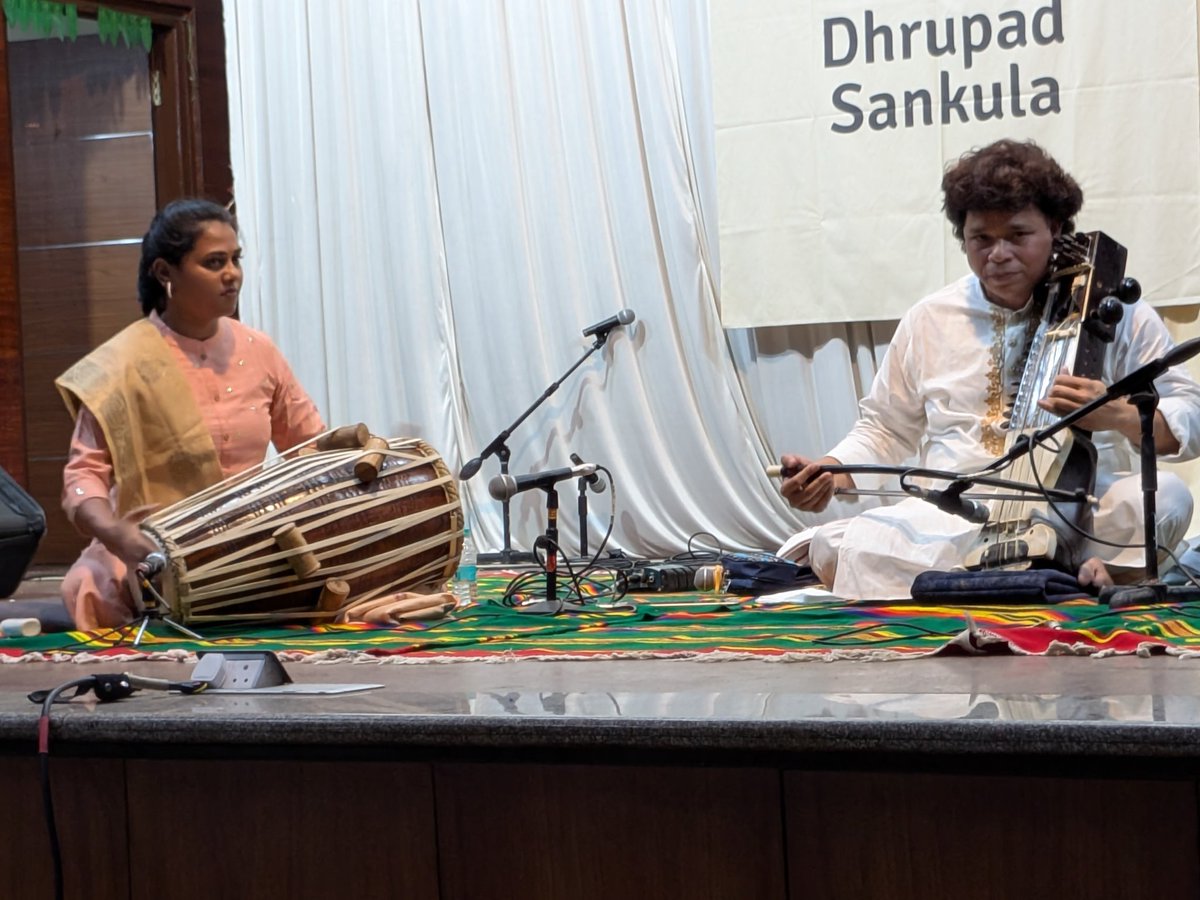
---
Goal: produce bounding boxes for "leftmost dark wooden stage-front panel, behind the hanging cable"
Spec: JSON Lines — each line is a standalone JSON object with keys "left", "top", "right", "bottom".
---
{"left": 0, "top": 758, "right": 130, "bottom": 900}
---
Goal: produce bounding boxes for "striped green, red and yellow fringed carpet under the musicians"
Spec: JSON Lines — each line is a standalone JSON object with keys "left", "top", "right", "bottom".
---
{"left": 0, "top": 574, "right": 1200, "bottom": 664}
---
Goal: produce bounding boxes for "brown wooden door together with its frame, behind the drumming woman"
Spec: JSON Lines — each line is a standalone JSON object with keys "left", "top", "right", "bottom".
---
{"left": 0, "top": 0, "right": 233, "bottom": 565}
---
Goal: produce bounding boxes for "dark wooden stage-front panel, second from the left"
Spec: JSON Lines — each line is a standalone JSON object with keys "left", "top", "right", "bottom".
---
{"left": 127, "top": 760, "right": 438, "bottom": 900}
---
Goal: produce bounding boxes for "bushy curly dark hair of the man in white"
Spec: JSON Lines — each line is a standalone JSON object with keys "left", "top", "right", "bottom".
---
{"left": 942, "top": 140, "right": 1084, "bottom": 240}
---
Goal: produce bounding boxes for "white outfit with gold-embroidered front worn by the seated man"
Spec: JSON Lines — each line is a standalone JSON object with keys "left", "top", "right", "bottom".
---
{"left": 809, "top": 275, "right": 1200, "bottom": 600}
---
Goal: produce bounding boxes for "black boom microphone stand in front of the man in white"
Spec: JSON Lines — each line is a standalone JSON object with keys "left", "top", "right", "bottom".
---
{"left": 965, "top": 337, "right": 1200, "bottom": 610}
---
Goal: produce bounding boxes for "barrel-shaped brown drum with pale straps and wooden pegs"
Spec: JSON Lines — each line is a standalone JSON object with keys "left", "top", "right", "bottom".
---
{"left": 142, "top": 438, "right": 463, "bottom": 623}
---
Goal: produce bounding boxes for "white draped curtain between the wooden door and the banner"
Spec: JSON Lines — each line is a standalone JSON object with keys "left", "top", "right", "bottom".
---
{"left": 224, "top": 0, "right": 890, "bottom": 557}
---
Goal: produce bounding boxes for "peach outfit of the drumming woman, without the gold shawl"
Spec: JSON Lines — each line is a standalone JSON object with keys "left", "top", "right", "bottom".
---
{"left": 62, "top": 313, "right": 325, "bottom": 630}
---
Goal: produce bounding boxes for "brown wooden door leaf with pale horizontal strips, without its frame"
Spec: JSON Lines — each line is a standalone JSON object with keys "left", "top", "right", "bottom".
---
{"left": 8, "top": 28, "right": 156, "bottom": 564}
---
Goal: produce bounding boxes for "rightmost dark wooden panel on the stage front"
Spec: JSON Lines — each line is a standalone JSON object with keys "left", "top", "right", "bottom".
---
{"left": 784, "top": 773, "right": 1200, "bottom": 900}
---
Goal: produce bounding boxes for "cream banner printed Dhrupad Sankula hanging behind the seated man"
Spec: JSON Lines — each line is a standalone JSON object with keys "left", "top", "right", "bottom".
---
{"left": 712, "top": 0, "right": 1200, "bottom": 328}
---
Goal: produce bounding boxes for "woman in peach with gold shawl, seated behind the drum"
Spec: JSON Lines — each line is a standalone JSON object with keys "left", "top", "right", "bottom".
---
{"left": 55, "top": 199, "right": 325, "bottom": 630}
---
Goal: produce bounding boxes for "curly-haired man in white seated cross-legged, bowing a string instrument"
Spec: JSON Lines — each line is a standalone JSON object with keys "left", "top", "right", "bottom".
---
{"left": 780, "top": 140, "right": 1200, "bottom": 600}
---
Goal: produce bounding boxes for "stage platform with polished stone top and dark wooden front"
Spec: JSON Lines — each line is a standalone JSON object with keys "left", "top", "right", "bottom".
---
{"left": 0, "top": 655, "right": 1200, "bottom": 900}
